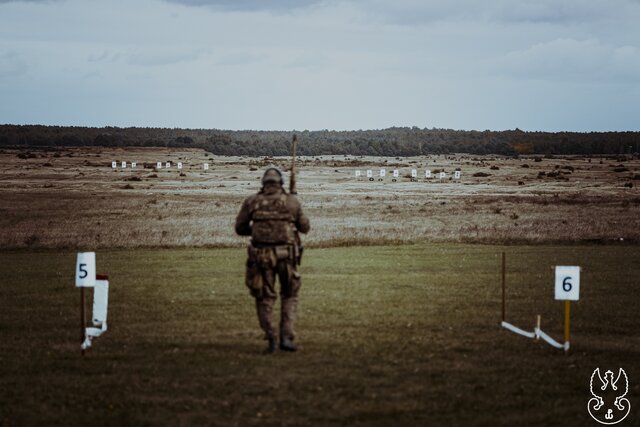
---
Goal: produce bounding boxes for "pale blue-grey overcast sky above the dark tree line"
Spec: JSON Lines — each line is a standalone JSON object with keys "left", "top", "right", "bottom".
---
{"left": 0, "top": 0, "right": 640, "bottom": 131}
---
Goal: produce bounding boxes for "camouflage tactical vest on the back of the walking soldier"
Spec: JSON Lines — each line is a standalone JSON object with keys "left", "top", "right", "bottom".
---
{"left": 251, "top": 193, "right": 295, "bottom": 245}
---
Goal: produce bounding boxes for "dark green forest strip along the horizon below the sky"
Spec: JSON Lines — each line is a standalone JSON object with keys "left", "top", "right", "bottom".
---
{"left": 0, "top": 125, "right": 640, "bottom": 157}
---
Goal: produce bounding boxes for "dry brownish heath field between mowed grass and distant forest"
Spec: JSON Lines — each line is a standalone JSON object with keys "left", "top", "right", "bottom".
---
{"left": 0, "top": 147, "right": 640, "bottom": 248}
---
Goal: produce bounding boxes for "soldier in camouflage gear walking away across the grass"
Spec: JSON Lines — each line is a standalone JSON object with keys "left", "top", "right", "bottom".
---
{"left": 235, "top": 168, "right": 309, "bottom": 353}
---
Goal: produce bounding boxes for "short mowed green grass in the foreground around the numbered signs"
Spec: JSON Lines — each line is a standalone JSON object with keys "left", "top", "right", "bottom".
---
{"left": 0, "top": 244, "right": 640, "bottom": 426}
